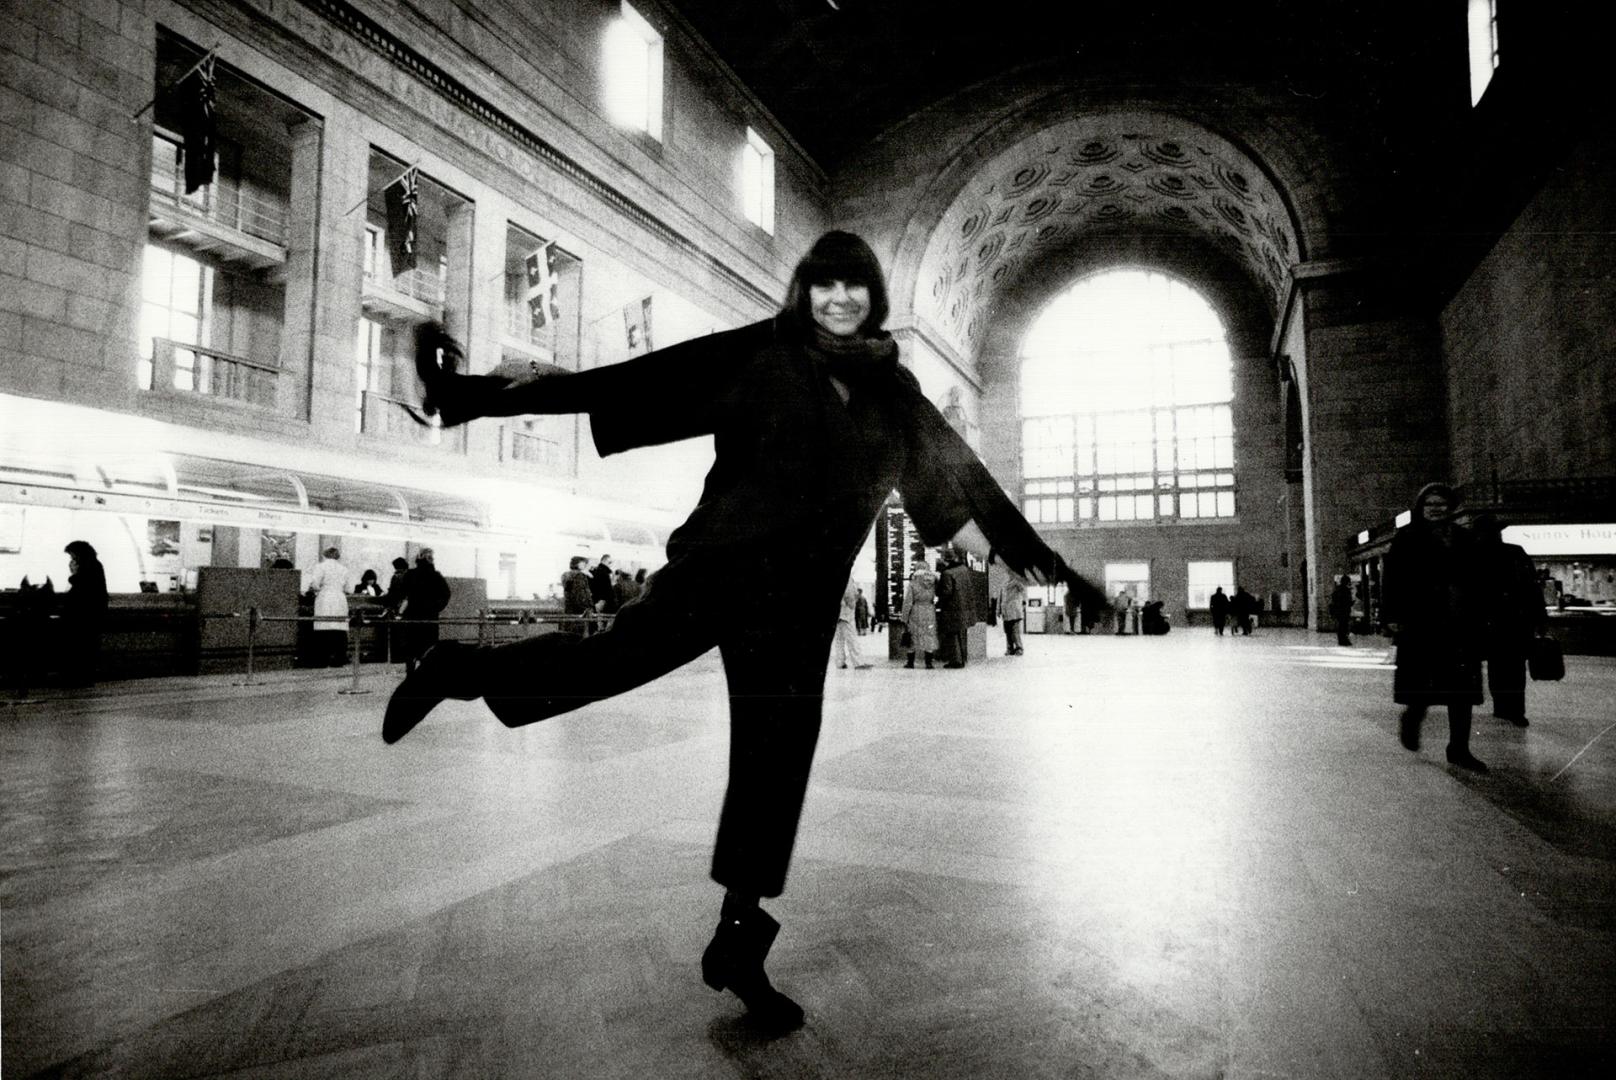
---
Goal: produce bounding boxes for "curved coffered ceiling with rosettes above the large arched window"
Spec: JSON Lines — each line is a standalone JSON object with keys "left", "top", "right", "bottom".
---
{"left": 915, "top": 112, "right": 1298, "bottom": 359}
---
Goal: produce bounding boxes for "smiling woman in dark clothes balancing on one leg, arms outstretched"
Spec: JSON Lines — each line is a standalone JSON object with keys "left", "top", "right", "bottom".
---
{"left": 381, "top": 231, "right": 1092, "bottom": 1031}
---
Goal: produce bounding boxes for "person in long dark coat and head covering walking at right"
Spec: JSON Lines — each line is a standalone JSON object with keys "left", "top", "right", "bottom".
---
{"left": 1380, "top": 483, "right": 1487, "bottom": 773}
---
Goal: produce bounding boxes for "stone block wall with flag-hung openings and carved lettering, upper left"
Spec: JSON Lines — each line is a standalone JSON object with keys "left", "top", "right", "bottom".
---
{"left": 0, "top": 0, "right": 826, "bottom": 495}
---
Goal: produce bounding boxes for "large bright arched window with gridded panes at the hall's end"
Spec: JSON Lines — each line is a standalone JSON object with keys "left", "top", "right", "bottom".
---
{"left": 1021, "top": 270, "right": 1235, "bottom": 525}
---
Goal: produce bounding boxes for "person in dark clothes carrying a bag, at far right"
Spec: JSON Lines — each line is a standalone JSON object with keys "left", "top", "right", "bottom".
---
{"left": 1471, "top": 514, "right": 1548, "bottom": 728}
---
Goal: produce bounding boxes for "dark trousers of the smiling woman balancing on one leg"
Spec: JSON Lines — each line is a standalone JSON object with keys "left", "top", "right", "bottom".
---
{"left": 459, "top": 556, "right": 847, "bottom": 896}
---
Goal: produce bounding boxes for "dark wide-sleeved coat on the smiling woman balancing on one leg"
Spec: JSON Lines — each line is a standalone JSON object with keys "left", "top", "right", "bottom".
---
{"left": 536, "top": 317, "right": 1060, "bottom": 578}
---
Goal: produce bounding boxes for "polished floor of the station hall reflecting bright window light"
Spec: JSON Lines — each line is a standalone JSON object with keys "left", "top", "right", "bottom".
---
{"left": 0, "top": 629, "right": 1616, "bottom": 1080}
